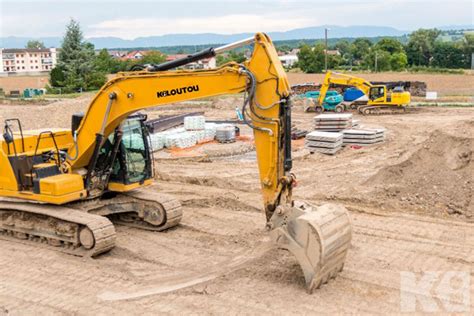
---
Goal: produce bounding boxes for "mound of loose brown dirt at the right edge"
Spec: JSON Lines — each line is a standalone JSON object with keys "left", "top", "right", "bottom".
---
{"left": 367, "top": 128, "right": 474, "bottom": 218}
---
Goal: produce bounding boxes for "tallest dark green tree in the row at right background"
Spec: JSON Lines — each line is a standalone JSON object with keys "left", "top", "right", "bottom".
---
{"left": 406, "top": 29, "right": 441, "bottom": 66}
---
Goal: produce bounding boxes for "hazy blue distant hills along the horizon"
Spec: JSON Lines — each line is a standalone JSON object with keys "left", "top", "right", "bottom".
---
{"left": 0, "top": 25, "right": 472, "bottom": 48}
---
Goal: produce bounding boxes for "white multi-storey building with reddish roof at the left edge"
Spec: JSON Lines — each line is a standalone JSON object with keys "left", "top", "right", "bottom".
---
{"left": 0, "top": 48, "right": 57, "bottom": 73}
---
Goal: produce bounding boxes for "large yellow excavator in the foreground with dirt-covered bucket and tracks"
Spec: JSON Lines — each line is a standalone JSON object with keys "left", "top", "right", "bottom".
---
{"left": 0, "top": 33, "right": 352, "bottom": 291}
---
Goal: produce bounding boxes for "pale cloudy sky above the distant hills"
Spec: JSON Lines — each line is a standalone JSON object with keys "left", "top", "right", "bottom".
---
{"left": 0, "top": 0, "right": 474, "bottom": 39}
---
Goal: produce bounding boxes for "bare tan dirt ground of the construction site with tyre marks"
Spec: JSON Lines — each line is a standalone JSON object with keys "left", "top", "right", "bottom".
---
{"left": 0, "top": 95, "right": 474, "bottom": 315}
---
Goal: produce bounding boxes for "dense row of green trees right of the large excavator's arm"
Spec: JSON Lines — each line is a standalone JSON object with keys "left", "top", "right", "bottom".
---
{"left": 295, "top": 29, "right": 474, "bottom": 73}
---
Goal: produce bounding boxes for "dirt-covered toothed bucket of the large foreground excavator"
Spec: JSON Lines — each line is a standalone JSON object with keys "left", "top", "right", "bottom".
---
{"left": 270, "top": 202, "right": 352, "bottom": 293}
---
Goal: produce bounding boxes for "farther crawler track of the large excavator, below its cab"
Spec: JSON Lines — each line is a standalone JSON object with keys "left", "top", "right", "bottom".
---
{"left": 71, "top": 189, "right": 183, "bottom": 231}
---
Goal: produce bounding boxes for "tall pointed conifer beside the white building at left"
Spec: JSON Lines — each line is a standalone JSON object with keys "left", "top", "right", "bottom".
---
{"left": 50, "top": 19, "right": 106, "bottom": 92}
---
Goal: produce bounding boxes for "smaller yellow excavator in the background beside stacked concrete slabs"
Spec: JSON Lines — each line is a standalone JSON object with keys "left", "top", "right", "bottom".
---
{"left": 317, "top": 71, "right": 411, "bottom": 115}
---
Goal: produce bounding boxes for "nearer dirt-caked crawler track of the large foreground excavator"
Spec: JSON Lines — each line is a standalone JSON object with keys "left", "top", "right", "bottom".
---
{"left": 0, "top": 199, "right": 116, "bottom": 257}
